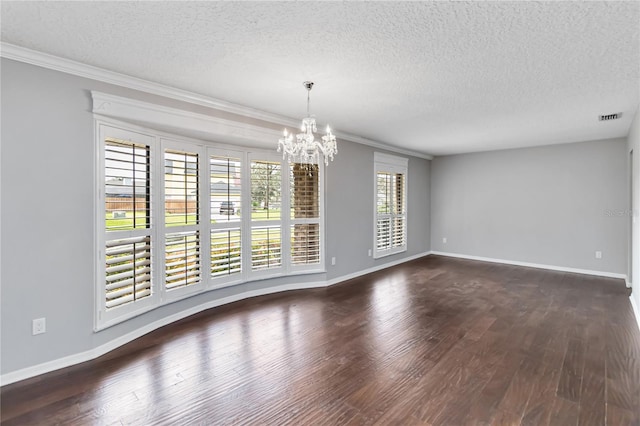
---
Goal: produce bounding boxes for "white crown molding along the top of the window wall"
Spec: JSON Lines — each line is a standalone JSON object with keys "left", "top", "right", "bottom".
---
{"left": 0, "top": 42, "right": 433, "bottom": 160}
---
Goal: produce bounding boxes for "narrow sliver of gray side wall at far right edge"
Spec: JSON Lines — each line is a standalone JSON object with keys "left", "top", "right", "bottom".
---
{"left": 627, "top": 108, "right": 640, "bottom": 306}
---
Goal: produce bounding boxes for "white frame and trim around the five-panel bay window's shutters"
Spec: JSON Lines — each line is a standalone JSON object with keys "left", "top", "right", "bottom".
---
{"left": 94, "top": 114, "right": 326, "bottom": 331}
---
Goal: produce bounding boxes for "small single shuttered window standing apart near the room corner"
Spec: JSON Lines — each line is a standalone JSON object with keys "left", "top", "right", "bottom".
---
{"left": 374, "top": 152, "right": 408, "bottom": 258}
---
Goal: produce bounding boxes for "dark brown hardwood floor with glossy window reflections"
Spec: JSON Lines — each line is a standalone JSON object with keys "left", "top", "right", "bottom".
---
{"left": 1, "top": 256, "right": 640, "bottom": 425}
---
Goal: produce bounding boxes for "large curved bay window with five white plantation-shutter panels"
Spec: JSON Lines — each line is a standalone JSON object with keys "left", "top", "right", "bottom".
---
{"left": 96, "top": 119, "right": 324, "bottom": 329}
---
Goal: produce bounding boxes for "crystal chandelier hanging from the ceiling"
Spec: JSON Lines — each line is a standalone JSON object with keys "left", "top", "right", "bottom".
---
{"left": 278, "top": 81, "right": 338, "bottom": 165}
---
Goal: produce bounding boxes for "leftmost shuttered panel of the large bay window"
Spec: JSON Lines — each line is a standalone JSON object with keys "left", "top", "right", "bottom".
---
{"left": 96, "top": 126, "right": 156, "bottom": 322}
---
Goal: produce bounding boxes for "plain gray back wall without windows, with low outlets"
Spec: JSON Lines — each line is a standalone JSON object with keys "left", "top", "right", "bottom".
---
{"left": 431, "top": 139, "right": 628, "bottom": 274}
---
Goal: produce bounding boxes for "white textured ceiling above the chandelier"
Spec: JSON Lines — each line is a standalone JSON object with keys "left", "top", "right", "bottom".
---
{"left": 1, "top": 1, "right": 640, "bottom": 155}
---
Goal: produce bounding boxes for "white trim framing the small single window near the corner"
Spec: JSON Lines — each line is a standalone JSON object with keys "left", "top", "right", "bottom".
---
{"left": 373, "top": 152, "right": 409, "bottom": 259}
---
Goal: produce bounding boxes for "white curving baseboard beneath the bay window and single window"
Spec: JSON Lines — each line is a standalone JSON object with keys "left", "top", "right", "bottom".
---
{"left": 0, "top": 252, "right": 430, "bottom": 386}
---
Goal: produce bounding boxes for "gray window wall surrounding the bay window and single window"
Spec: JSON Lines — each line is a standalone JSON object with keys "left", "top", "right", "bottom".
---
{"left": 0, "top": 59, "right": 430, "bottom": 374}
